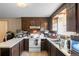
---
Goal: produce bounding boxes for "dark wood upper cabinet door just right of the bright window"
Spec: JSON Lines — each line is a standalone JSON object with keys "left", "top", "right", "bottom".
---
{"left": 67, "top": 6, "right": 76, "bottom": 32}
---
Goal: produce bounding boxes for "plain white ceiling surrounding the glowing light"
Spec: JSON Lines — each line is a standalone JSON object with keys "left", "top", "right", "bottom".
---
{"left": 0, "top": 3, "right": 62, "bottom": 18}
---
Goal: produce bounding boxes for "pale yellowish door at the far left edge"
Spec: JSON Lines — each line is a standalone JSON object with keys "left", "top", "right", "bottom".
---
{"left": 0, "top": 21, "right": 7, "bottom": 42}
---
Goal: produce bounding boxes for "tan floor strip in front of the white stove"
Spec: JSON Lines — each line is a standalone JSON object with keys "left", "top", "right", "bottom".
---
{"left": 21, "top": 51, "right": 48, "bottom": 56}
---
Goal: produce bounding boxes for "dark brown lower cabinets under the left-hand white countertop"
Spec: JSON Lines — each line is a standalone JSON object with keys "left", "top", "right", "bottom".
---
{"left": 0, "top": 39, "right": 29, "bottom": 56}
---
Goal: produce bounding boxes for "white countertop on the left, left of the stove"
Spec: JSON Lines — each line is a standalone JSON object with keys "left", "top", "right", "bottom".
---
{"left": 0, "top": 37, "right": 28, "bottom": 48}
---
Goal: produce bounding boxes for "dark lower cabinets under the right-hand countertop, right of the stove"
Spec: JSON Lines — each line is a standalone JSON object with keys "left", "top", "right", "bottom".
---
{"left": 47, "top": 40, "right": 65, "bottom": 56}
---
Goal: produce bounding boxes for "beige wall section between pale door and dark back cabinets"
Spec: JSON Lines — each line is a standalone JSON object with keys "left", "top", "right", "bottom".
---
{"left": 7, "top": 18, "right": 21, "bottom": 32}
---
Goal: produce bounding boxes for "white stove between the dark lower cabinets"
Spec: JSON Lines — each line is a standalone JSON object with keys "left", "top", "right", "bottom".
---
{"left": 29, "top": 34, "right": 41, "bottom": 52}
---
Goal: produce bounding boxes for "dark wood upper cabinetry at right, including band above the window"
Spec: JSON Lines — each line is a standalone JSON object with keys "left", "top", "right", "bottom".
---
{"left": 51, "top": 3, "right": 76, "bottom": 32}
